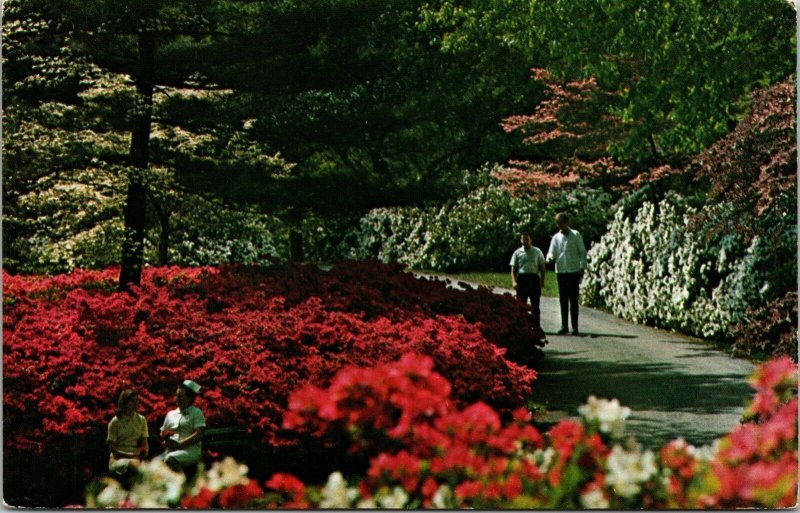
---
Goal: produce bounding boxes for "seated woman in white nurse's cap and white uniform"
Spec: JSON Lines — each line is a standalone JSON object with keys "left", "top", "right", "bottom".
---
{"left": 161, "top": 379, "right": 206, "bottom": 472}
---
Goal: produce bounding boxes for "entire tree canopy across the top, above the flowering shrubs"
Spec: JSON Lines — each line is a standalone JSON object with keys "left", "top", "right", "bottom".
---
{"left": 3, "top": 0, "right": 795, "bottom": 276}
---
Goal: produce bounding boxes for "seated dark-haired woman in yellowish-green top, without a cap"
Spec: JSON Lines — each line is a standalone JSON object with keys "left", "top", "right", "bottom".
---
{"left": 106, "top": 390, "right": 150, "bottom": 475}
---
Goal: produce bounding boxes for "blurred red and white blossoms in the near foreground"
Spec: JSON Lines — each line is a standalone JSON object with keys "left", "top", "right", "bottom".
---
{"left": 86, "top": 353, "right": 798, "bottom": 509}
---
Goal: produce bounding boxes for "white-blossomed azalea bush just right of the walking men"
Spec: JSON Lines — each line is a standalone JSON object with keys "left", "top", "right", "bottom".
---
{"left": 582, "top": 193, "right": 797, "bottom": 337}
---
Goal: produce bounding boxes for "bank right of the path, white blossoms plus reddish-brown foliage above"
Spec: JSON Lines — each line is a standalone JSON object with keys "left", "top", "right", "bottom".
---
{"left": 584, "top": 80, "right": 797, "bottom": 358}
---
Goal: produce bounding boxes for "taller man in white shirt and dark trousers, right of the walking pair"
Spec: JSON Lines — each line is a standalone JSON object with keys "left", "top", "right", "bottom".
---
{"left": 547, "top": 212, "right": 586, "bottom": 335}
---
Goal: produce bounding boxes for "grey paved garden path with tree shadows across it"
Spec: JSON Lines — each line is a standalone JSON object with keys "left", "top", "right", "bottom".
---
{"left": 418, "top": 276, "right": 755, "bottom": 449}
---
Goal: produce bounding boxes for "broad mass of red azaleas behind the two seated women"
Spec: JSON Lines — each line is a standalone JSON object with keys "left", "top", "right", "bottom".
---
{"left": 3, "top": 262, "right": 544, "bottom": 505}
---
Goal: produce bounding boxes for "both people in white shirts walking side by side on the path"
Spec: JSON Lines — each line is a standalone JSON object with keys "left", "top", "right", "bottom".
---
{"left": 510, "top": 212, "right": 586, "bottom": 335}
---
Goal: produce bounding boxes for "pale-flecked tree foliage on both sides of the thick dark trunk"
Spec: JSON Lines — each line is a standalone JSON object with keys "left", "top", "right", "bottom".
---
{"left": 3, "top": 0, "right": 286, "bottom": 272}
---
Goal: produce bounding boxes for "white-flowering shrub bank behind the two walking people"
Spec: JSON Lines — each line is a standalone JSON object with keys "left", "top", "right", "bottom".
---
{"left": 309, "top": 168, "right": 612, "bottom": 270}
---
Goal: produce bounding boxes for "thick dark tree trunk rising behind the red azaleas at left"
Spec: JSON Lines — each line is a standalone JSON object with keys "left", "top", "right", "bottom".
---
{"left": 119, "top": 32, "right": 156, "bottom": 291}
